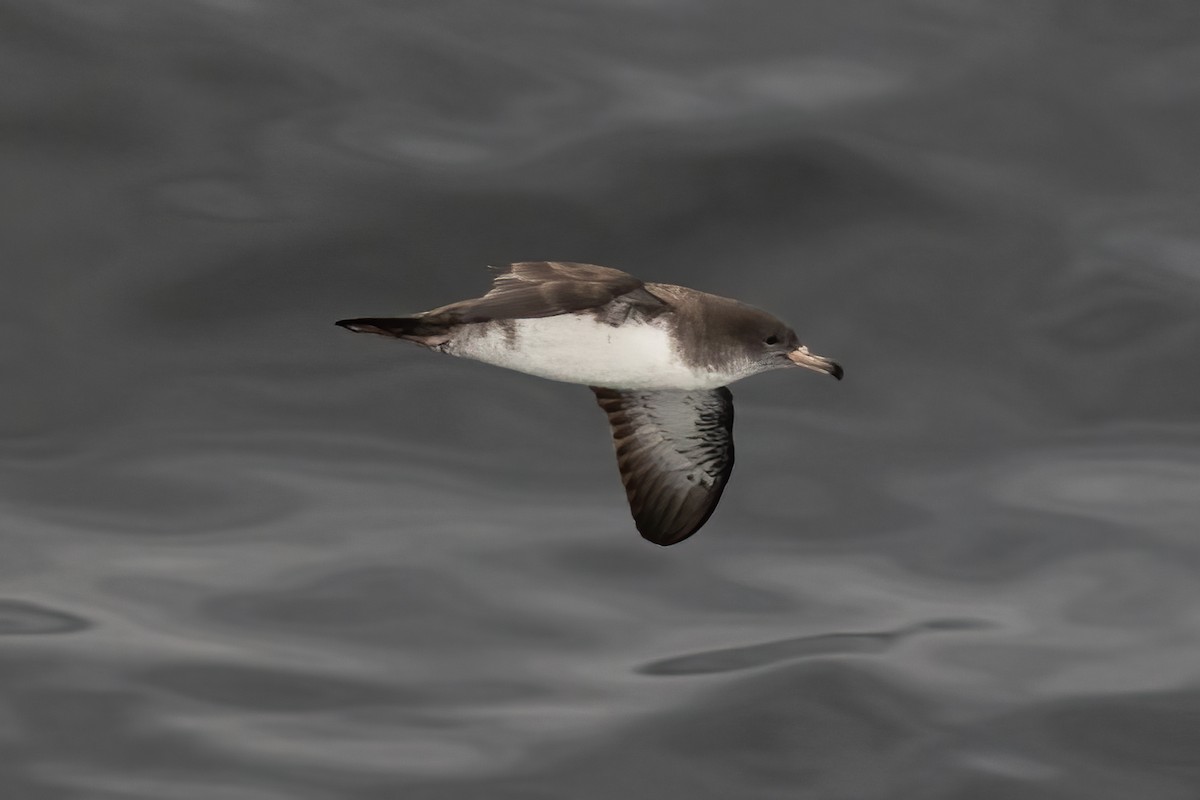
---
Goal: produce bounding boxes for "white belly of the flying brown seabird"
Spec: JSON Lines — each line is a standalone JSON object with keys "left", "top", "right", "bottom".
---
{"left": 446, "top": 314, "right": 740, "bottom": 389}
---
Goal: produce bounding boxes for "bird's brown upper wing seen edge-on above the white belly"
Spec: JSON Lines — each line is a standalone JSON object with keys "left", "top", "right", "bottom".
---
{"left": 424, "top": 261, "right": 666, "bottom": 323}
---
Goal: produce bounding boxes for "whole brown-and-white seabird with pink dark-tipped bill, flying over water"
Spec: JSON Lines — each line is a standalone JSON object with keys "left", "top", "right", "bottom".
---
{"left": 336, "top": 261, "right": 842, "bottom": 546}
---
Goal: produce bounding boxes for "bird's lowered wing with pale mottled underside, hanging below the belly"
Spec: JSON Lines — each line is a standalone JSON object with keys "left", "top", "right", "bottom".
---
{"left": 592, "top": 386, "right": 733, "bottom": 546}
